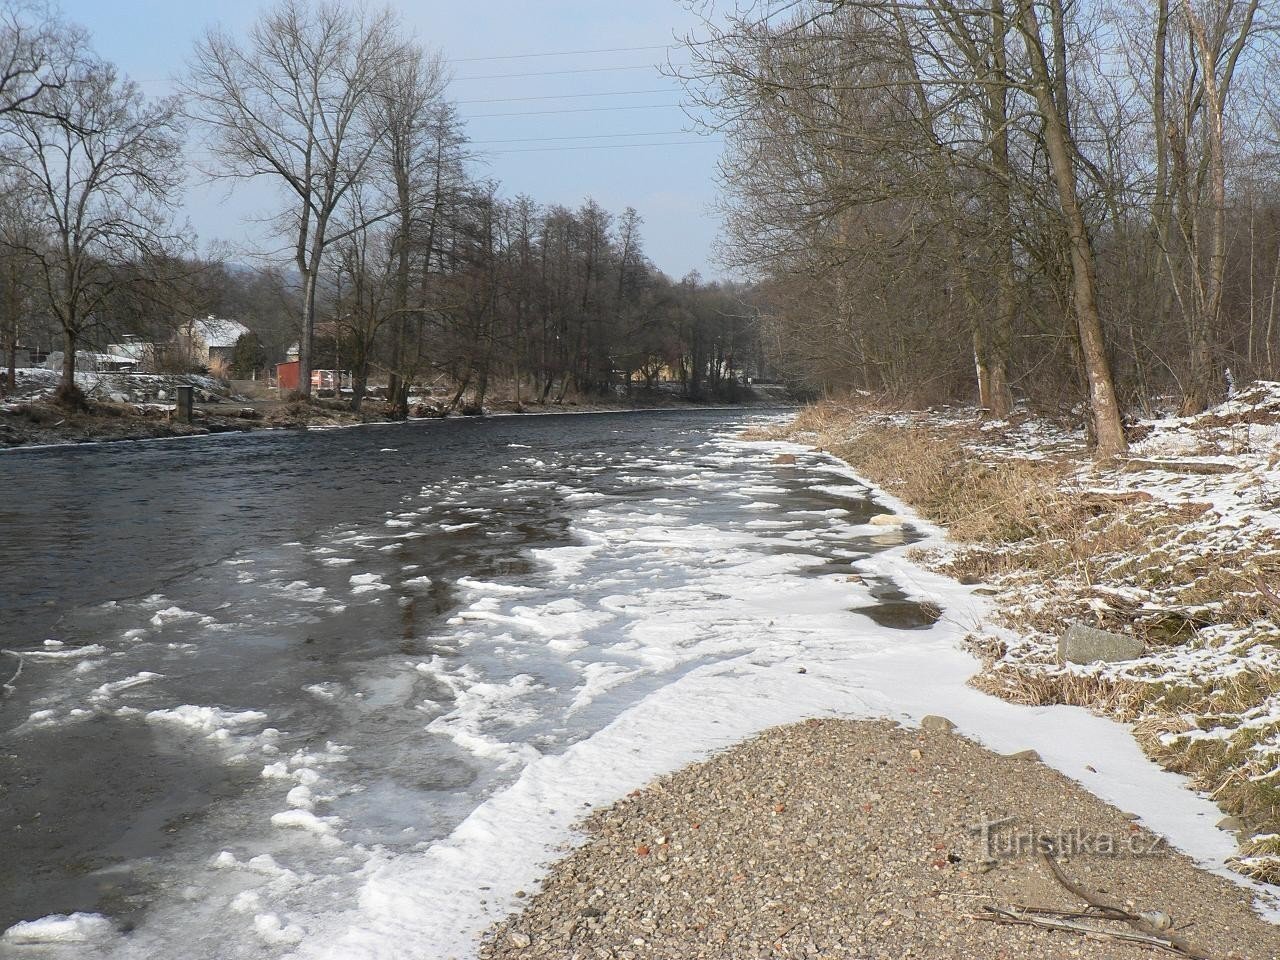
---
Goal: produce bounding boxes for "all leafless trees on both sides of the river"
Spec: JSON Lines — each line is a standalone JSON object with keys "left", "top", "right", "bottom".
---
{"left": 0, "top": 0, "right": 1280, "bottom": 453}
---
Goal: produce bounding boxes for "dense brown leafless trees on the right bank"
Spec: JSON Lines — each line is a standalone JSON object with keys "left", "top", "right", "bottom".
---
{"left": 676, "top": 0, "right": 1280, "bottom": 453}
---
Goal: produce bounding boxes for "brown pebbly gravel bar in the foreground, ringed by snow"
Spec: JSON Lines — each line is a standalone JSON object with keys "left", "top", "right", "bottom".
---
{"left": 480, "top": 721, "right": 1280, "bottom": 960}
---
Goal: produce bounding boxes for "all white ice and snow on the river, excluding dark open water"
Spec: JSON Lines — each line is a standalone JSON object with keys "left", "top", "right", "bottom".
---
{"left": 0, "top": 417, "right": 1276, "bottom": 960}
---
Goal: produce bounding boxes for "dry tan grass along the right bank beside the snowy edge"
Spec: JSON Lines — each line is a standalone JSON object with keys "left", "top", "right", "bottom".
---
{"left": 762, "top": 402, "right": 1280, "bottom": 879}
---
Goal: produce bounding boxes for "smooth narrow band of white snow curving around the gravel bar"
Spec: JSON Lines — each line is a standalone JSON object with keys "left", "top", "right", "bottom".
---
{"left": 296, "top": 442, "right": 1280, "bottom": 959}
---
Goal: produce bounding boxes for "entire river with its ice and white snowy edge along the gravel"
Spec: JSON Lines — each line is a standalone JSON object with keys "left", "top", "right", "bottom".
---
{"left": 0, "top": 411, "right": 1275, "bottom": 960}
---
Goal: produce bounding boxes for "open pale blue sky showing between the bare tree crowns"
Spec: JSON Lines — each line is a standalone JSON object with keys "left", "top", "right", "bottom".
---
{"left": 61, "top": 0, "right": 721, "bottom": 284}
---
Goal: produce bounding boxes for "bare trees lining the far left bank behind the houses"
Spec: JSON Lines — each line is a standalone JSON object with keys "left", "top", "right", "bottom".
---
{"left": 0, "top": 0, "right": 764, "bottom": 416}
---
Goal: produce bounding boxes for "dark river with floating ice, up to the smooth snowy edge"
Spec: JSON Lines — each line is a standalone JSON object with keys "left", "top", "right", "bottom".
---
{"left": 0, "top": 411, "right": 937, "bottom": 957}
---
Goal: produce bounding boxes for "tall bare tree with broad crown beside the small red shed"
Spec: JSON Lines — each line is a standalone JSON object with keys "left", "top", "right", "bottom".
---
{"left": 187, "top": 0, "right": 402, "bottom": 394}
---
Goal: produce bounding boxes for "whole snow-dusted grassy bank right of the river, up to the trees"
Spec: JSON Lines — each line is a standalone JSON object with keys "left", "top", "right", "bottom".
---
{"left": 747, "top": 384, "right": 1280, "bottom": 882}
